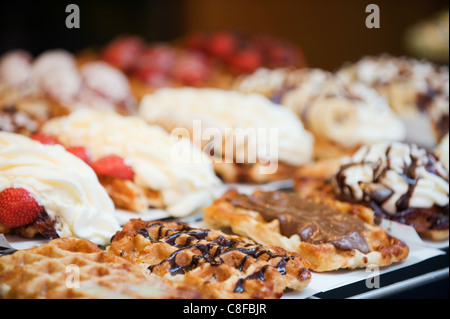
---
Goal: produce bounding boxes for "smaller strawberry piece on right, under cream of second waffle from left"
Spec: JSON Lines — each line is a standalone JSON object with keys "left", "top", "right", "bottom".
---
{"left": 91, "top": 155, "right": 134, "bottom": 181}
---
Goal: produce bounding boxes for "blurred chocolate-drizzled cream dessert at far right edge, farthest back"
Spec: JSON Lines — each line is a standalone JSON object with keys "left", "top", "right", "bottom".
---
{"left": 338, "top": 54, "right": 449, "bottom": 146}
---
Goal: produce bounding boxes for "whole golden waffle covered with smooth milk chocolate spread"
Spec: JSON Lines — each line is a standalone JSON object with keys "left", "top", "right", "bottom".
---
{"left": 204, "top": 190, "right": 409, "bottom": 272}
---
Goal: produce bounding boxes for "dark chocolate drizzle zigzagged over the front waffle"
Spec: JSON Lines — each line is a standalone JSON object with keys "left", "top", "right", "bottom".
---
{"left": 135, "top": 222, "right": 310, "bottom": 293}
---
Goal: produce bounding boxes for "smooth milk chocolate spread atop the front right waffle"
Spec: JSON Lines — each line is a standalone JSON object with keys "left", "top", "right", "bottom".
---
{"left": 229, "top": 191, "right": 370, "bottom": 253}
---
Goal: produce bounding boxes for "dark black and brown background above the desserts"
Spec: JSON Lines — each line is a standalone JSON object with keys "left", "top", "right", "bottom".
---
{"left": 0, "top": 0, "right": 448, "bottom": 69}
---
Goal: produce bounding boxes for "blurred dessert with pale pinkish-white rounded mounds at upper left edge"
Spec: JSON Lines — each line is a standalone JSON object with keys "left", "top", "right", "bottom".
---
{"left": 0, "top": 50, "right": 136, "bottom": 134}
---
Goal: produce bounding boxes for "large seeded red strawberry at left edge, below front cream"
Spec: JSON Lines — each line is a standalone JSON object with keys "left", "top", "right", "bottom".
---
{"left": 0, "top": 188, "right": 44, "bottom": 228}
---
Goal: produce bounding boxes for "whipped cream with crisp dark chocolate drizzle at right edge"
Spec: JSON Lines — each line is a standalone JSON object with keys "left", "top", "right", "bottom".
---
{"left": 335, "top": 142, "right": 449, "bottom": 215}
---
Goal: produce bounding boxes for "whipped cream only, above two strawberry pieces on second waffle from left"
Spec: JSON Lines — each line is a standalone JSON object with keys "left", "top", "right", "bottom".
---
{"left": 42, "top": 109, "right": 221, "bottom": 216}
